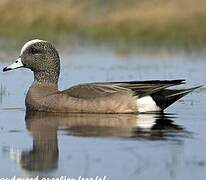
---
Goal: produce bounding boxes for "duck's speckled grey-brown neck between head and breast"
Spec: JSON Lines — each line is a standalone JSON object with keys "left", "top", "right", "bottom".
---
{"left": 33, "top": 70, "right": 59, "bottom": 89}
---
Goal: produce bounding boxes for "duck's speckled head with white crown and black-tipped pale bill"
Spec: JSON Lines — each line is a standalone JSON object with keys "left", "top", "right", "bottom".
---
{"left": 3, "top": 39, "right": 60, "bottom": 86}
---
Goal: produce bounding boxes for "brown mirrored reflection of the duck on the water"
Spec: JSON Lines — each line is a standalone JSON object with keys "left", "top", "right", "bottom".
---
{"left": 6, "top": 111, "right": 188, "bottom": 172}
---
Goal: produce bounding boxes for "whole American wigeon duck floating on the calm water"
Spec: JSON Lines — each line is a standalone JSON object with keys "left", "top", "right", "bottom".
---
{"left": 3, "top": 39, "right": 198, "bottom": 113}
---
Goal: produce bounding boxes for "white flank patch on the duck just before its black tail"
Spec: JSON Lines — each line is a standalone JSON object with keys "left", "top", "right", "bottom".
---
{"left": 137, "top": 96, "right": 161, "bottom": 112}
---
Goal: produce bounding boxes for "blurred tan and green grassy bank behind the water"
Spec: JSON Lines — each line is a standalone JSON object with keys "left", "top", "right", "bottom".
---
{"left": 0, "top": 0, "right": 206, "bottom": 46}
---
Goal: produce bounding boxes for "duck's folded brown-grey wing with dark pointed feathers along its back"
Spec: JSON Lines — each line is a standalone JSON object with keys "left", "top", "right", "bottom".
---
{"left": 62, "top": 79, "right": 184, "bottom": 99}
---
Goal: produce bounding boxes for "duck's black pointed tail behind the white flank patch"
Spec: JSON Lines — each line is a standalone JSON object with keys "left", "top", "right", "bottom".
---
{"left": 151, "top": 86, "right": 202, "bottom": 110}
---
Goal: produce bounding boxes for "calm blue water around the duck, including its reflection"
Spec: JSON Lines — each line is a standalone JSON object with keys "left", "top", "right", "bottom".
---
{"left": 0, "top": 41, "right": 206, "bottom": 180}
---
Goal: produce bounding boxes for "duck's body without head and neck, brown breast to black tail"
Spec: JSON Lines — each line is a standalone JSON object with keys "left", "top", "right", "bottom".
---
{"left": 26, "top": 80, "right": 198, "bottom": 113}
